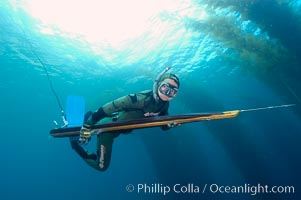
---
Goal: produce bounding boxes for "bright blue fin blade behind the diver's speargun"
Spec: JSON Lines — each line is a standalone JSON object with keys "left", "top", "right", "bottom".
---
{"left": 66, "top": 96, "right": 85, "bottom": 127}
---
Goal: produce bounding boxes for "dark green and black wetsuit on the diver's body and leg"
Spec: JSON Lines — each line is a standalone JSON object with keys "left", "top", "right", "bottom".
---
{"left": 71, "top": 90, "right": 169, "bottom": 171}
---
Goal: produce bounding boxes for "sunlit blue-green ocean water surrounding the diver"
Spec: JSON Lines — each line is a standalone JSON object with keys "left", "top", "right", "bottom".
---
{"left": 0, "top": 0, "right": 301, "bottom": 200}
